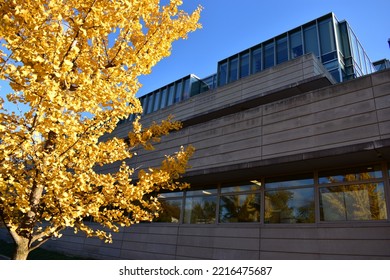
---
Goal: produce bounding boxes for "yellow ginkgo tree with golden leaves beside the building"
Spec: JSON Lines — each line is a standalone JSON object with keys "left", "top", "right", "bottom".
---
{"left": 0, "top": 0, "right": 201, "bottom": 259}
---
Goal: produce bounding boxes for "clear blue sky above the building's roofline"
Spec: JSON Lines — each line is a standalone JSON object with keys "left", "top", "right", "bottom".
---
{"left": 138, "top": 0, "right": 390, "bottom": 96}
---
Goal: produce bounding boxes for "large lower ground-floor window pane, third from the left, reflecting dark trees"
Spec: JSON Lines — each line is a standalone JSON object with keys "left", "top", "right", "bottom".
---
{"left": 219, "top": 194, "right": 260, "bottom": 223}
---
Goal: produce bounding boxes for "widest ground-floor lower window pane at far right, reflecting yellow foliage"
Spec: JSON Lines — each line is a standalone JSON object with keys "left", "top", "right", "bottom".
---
{"left": 320, "top": 183, "right": 387, "bottom": 221}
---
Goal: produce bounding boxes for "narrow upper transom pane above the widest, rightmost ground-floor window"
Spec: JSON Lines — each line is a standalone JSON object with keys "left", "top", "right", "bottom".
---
{"left": 319, "top": 165, "right": 382, "bottom": 184}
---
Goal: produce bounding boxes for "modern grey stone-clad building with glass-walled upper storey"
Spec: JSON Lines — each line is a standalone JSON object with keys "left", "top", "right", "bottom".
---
{"left": 0, "top": 14, "right": 390, "bottom": 259}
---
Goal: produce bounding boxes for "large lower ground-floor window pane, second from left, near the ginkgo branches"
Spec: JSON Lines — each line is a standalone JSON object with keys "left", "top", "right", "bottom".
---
{"left": 184, "top": 196, "right": 217, "bottom": 224}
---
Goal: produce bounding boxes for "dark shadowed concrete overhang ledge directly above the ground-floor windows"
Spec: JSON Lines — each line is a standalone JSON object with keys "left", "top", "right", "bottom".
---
{"left": 183, "top": 138, "right": 390, "bottom": 187}
